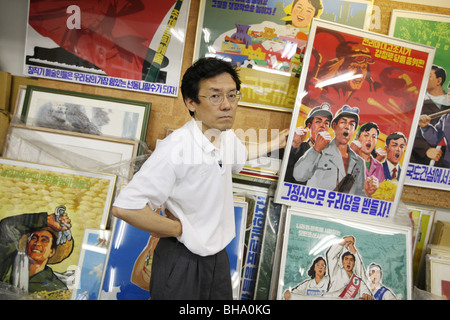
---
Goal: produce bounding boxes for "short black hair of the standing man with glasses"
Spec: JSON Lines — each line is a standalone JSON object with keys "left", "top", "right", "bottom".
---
{"left": 181, "top": 57, "right": 241, "bottom": 116}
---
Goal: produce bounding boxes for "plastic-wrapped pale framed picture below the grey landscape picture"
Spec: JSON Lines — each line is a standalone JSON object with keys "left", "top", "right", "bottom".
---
{"left": 3, "top": 124, "right": 138, "bottom": 179}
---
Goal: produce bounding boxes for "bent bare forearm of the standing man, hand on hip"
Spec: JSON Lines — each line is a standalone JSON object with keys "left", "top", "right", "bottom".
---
{"left": 112, "top": 206, "right": 182, "bottom": 238}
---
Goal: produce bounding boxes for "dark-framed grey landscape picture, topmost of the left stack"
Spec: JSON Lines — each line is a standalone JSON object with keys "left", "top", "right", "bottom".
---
{"left": 21, "top": 86, "right": 151, "bottom": 141}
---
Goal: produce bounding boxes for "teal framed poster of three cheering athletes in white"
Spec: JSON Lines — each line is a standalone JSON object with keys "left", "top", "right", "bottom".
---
{"left": 277, "top": 209, "right": 412, "bottom": 300}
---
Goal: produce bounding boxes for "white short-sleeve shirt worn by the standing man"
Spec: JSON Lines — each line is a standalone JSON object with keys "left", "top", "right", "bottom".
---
{"left": 114, "top": 119, "right": 247, "bottom": 256}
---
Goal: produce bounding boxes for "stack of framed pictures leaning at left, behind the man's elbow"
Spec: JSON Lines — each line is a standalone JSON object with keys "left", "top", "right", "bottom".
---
{"left": 0, "top": 86, "right": 151, "bottom": 300}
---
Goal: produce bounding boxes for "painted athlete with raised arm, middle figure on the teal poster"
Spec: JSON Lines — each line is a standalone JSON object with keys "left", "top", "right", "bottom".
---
{"left": 324, "top": 236, "right": 372, "bottom": 300}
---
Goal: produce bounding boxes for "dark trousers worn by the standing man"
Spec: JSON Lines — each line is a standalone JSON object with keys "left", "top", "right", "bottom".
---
{"left": 150, "top": 238, "right": 233, "bottom": 300}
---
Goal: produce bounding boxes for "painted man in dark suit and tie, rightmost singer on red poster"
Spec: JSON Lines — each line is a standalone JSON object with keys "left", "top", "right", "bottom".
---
{"left": 383, "top": 132, "right": 407, "bottom": 180}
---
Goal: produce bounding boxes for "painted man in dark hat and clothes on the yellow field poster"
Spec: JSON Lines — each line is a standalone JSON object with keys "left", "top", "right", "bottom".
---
{"left": 0, "top": 206, "right": 74, "bottom": 293}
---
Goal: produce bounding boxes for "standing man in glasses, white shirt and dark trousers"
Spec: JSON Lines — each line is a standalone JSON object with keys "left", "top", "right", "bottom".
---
{"left": 112, "top": 58, "right": 288, "bottom": 300}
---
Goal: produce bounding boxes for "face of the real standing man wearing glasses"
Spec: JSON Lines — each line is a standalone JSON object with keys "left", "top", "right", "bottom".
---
{"left": 186, "top": 73, "right": 238, "bottom": 133}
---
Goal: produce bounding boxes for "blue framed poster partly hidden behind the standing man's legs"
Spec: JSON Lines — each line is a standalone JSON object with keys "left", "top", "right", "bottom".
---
{"left": 100, "top": 199, "right": 247, "bottom": 300}
